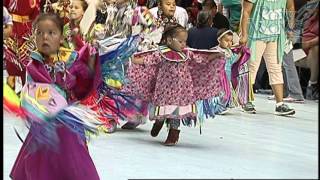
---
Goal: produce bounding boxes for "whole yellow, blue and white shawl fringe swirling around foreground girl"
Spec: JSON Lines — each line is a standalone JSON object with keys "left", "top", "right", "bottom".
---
{"left": 3, "top": 84, "right": 104, "bottom": 152}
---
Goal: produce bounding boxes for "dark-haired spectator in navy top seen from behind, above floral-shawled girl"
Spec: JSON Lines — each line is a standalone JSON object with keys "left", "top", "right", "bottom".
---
{"left": 187, "top": 11, "right": 218, "bottom": 49}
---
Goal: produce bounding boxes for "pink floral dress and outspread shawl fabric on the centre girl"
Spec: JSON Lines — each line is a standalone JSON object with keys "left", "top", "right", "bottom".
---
{"left": 124, "top": 45, "right": 225, "bottom": 120}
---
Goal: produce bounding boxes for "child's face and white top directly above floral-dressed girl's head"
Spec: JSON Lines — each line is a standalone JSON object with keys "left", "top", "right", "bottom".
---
{"left": 150, "top": 0, "right": 188, "bottom": 27}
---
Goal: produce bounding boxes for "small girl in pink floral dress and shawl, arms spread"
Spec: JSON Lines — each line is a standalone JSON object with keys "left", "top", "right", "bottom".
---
{"left": 124, "top": 24, "right": 224, "bottom": 146}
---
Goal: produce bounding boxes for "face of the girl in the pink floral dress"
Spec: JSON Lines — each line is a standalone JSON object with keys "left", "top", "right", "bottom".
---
{"left": 167, "top": 31, "right": 188, "bottom": 52}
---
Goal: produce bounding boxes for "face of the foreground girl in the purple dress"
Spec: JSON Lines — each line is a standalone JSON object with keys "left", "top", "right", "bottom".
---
{"left": 35, "top": 19, "right": 63, "bottom": 56}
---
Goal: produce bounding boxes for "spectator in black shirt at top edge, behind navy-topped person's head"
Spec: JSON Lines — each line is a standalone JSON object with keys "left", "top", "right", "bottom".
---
{"left": 202, "top": 0, "right": 230, "bottom": 29}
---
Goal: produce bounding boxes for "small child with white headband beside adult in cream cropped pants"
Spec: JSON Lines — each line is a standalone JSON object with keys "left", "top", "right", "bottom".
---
{"left": 202, "top": 29, "right": 253, "bottom": 114}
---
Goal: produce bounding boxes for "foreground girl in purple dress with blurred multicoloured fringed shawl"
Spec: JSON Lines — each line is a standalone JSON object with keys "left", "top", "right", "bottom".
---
{"left": 10, "top": 14, "right": 100, "bottom": 180}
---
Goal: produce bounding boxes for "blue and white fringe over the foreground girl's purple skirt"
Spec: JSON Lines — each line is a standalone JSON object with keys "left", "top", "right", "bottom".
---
{"left": 27, "top": 104, "right": 102, "bottom": 152}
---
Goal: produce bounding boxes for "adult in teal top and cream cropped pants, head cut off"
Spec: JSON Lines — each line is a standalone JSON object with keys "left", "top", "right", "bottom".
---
{"left": 240, "top": 0, "right": 295, "bottom": 116}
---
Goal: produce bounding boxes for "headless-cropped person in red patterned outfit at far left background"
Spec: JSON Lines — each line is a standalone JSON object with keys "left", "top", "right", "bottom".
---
{"left": 3, "top": 0, "right": 40, "bottom": 88}
